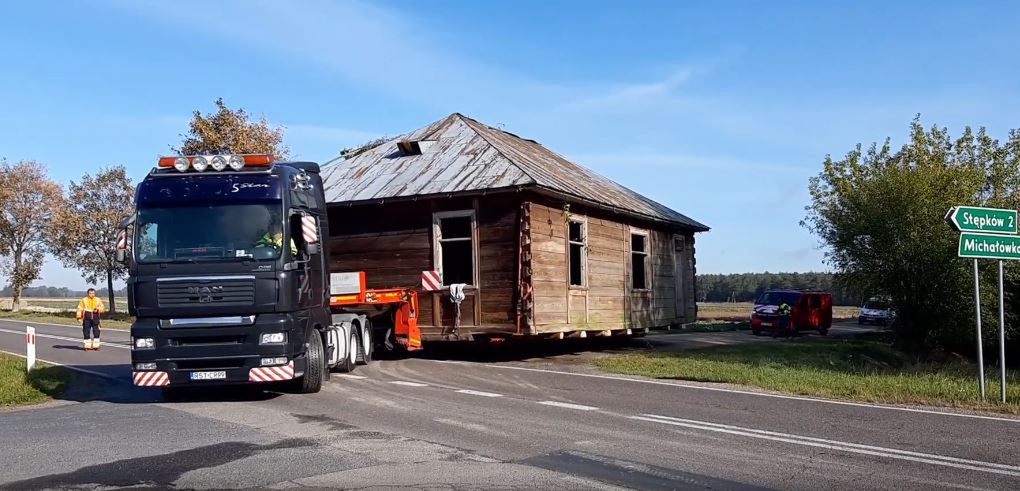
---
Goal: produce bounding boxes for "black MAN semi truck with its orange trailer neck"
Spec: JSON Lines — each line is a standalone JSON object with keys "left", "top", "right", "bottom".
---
{"left": 116, "top": 154, "right": 421, "bottom": 395}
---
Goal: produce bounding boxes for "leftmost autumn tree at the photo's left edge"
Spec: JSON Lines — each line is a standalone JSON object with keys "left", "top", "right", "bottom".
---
{"left": 0, "top": 160, "right": 62, "bottom": 310}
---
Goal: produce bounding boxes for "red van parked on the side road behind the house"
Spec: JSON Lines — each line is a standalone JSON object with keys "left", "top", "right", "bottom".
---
{"left": 751, "top": 290, "right": 832, "bottom": 336}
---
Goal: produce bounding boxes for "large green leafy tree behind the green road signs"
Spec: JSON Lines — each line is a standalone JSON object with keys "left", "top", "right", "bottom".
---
{"left": 803, "top": 117, "right": 1003, "bottom": 352}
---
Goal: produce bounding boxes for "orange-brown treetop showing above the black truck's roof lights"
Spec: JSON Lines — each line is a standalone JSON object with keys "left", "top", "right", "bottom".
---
{"left": 170, "top": 98, "right": 290, "bottom": 159}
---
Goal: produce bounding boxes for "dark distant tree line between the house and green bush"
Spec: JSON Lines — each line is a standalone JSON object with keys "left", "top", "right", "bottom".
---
{"left": 697, "top": 273, "right": 864, "bottom": 305}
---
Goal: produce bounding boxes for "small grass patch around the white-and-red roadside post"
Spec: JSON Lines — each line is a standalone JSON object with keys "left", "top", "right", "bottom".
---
{"left": 0, "top": 353, "right": 71, "bottom": 407}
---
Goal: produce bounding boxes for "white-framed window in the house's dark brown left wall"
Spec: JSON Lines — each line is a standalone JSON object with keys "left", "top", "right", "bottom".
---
{"left": 434, "top": 210, "right": 474, "bottom": 285}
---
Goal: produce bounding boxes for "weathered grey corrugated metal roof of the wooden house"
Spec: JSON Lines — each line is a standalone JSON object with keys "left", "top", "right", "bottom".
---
{"left": 322, "top": 113, "right": 708, "bottom": 231}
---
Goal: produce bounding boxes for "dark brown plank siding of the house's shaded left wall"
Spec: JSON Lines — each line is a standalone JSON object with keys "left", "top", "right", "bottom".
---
{"left": 329, "top": 196, "right": 519, "bottom": 338}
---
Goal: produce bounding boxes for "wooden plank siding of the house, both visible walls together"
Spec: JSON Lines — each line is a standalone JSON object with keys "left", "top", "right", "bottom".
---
{"left": 328, "top": 193, "right": 697, "bottom": 339}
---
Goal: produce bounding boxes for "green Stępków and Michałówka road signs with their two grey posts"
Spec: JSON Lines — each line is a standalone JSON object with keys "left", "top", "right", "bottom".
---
{"left": 946, "top": 206, "right": 1020, "bottom": 402}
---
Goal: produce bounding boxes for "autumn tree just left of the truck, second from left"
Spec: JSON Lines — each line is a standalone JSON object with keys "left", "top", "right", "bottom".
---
{"left": 49, "top": 165, "right": 135, "bottom": 312}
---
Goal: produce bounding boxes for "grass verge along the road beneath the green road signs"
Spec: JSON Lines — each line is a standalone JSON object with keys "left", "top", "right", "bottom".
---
{"left": 595, "top": 338, "right": 1020, "bottom": 414}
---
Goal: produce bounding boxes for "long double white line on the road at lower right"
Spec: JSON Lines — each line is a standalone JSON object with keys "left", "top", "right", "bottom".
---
{"left": 630, "top": 414, "right": 1020, "bottom": 477}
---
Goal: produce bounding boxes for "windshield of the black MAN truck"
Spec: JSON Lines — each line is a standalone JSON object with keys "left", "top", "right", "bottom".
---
{"left": 135, "top": 204, "right": 284, "bottom": 262}
